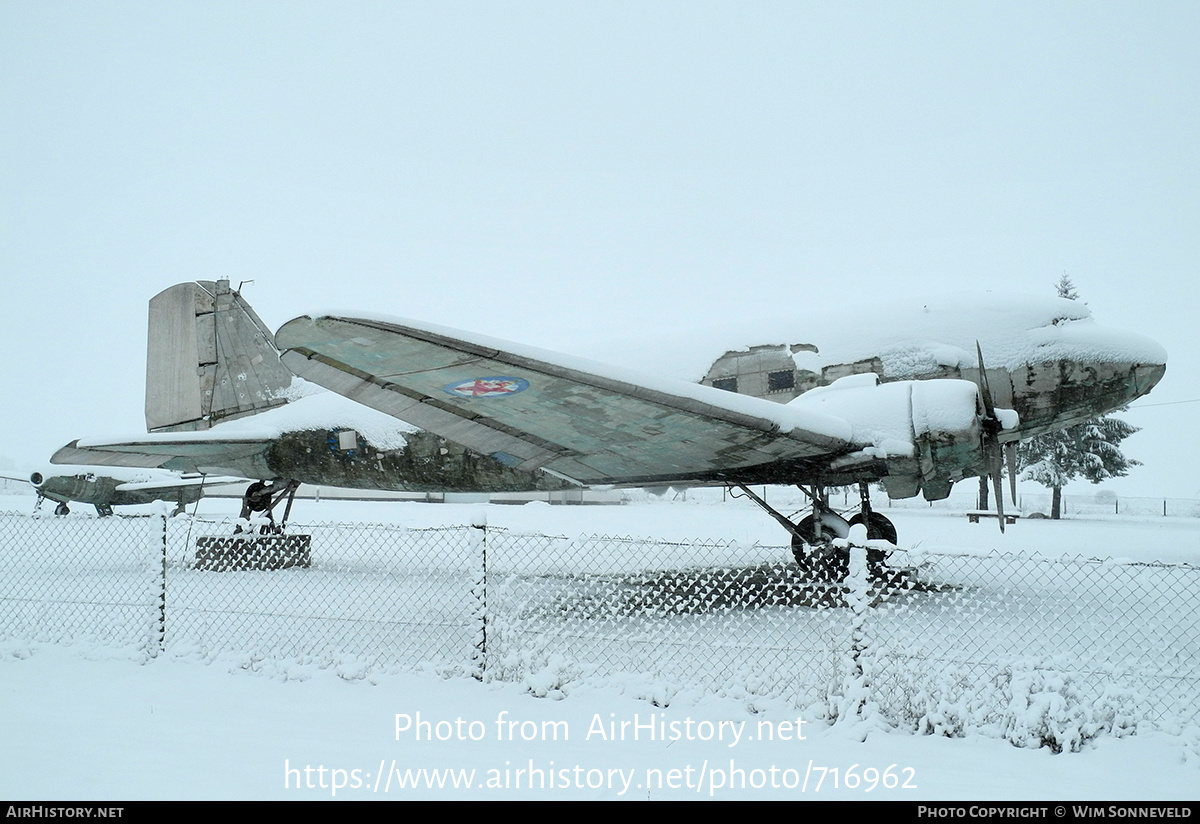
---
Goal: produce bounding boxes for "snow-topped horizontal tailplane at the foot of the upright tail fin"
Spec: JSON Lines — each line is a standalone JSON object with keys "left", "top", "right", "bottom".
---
{"left": 50, "top": 433, "right": 275, "bottom": 477}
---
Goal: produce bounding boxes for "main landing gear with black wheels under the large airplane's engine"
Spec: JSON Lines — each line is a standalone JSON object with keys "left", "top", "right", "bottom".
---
{"left": 734, "top": 482, "right": 896, "bottom": 581}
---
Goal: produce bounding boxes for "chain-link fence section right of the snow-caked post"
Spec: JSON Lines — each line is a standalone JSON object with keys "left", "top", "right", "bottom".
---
{"left": 863, "top": 552, "right": 1200, "bottom": 748}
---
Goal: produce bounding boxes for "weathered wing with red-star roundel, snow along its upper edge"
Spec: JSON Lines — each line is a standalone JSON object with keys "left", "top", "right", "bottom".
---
{"left": 276, "top": 315, "right": 853, "bottom": 485}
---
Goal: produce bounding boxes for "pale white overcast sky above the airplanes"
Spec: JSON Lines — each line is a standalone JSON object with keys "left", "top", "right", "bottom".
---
{"left": 0, "top": 0, "right": 1200, "bottom": 495}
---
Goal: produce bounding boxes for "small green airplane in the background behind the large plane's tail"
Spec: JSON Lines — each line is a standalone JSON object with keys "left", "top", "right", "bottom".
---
{"left": 0, "top": 467, "right": 238, "bottom": 518}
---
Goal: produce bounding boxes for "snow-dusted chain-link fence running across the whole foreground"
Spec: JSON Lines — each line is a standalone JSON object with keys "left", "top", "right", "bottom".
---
{"left": 0, "top": 515, "right": 1200, "bottom": 748}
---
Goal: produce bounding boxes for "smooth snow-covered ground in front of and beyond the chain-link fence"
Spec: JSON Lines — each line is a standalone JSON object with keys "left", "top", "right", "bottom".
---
{"left": 0, "top": 491, "right": 1200, "bottom": 800}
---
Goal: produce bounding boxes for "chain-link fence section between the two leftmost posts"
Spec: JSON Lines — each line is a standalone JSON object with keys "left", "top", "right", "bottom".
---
{"left": 164, "top": 518, "right": 485, "bottom": 673}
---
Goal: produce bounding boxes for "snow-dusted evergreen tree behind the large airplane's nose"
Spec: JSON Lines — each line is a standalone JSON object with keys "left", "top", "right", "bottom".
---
{"left": 1016, "top": 280, "right": 1140, "bottom": 519}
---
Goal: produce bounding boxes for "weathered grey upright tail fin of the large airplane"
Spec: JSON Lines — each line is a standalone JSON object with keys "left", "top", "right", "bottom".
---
{"left": 146, "top": 279, "right": 292, "bottom": 432}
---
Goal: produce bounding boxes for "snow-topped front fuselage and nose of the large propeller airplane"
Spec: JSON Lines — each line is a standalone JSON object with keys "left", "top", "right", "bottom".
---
{"left": 691, "top": 296, "right": 1166, "bottom": 440}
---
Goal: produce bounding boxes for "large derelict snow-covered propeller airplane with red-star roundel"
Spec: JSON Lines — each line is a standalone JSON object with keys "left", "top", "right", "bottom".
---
{"left": 53, "top": 282, "right": 1166, "bottom": 563}
